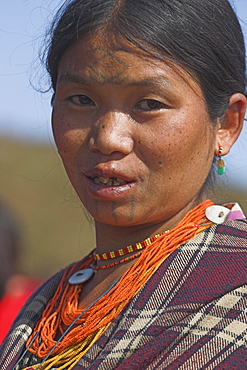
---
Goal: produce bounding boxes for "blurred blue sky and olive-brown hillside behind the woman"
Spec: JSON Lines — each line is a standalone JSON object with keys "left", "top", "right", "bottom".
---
{"left": 0, "top": 0, "right": 247, "bottom": 279}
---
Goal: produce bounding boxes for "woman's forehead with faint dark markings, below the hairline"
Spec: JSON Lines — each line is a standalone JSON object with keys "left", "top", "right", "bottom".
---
{"left": 58, "top": 37, "right": 200, "bottom": 91}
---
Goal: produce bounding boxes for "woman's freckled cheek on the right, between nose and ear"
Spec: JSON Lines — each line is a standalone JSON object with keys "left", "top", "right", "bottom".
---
{"left": 142, "top": 118, "right": 214, "bottom": 179}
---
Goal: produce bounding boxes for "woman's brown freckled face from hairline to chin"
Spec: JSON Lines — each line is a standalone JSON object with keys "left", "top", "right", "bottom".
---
{"left": 52, "top": 37, "right": 216, "bottom": 230}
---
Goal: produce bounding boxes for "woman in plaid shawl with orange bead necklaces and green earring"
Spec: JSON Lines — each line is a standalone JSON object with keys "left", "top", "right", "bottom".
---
{"left": 0, "top": 0, "right": 247, "bottom": 370}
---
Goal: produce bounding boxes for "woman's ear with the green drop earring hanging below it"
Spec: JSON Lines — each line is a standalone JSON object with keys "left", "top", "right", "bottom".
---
{"left": 215, "top": 93, "right": 246, "bottom": 155}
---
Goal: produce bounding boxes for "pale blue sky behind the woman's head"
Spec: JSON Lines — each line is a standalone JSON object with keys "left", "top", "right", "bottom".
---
{"left": 0, "top": 0, "right": 247, "bottom": 191}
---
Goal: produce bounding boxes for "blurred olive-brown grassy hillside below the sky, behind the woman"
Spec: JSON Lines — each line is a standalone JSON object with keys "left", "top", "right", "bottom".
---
{"left": 0, "top": 139, "right": 247, "bottom": 278}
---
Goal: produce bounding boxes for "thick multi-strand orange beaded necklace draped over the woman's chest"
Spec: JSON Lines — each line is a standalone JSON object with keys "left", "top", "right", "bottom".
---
{"left": 24, "top": 200, "right": 213, "bottom": 369}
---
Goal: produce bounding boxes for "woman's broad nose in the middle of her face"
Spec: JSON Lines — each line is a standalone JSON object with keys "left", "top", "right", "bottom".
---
{"left": 89, "top": 112, "right": 134, "bottom": 155}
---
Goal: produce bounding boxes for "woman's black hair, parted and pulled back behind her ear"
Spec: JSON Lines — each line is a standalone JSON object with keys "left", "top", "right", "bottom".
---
{"left": 46, "top": 0, "right": 246, "bottom": 120}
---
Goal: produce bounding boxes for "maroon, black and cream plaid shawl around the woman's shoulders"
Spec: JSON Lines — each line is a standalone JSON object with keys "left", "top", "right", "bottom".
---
{"left": 0, "top": 220, "right": 247, "bottom": 370}
